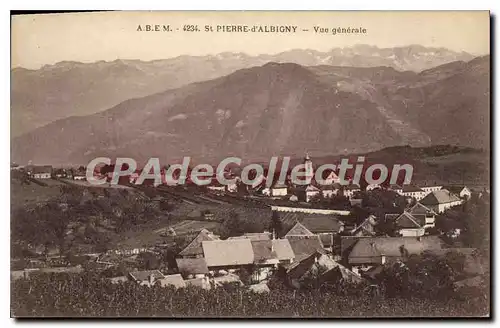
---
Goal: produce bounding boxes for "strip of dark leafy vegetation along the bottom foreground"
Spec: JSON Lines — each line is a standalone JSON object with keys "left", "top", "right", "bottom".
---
{"left": 11, "top": 273, "right": 489, "bottom": 317}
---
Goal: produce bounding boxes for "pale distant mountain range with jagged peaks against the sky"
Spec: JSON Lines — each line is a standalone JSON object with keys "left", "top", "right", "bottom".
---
{"left": 11, "top": 45, "right": 473, "bottom": 137}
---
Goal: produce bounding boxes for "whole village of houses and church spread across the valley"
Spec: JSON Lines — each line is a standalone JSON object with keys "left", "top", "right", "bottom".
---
{"left": 11, "top": 155, "right": 487, "bottom": 293}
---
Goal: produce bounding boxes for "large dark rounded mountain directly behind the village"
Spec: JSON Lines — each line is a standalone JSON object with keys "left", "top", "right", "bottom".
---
{"left": 12, "top": 52, "right": 490, "bottom": 164}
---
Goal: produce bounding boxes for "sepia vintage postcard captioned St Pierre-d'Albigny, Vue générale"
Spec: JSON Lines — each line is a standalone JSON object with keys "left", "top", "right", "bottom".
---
{"left": 10, "top": 11, "right": 491, "bottom": 318}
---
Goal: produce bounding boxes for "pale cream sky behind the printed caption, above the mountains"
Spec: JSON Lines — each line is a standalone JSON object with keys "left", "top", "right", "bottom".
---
{"left": 11, "top": 11, "right": 490, "bottom": 69}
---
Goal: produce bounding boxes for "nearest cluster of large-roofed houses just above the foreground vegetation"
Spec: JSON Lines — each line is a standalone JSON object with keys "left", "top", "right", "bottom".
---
{"left": 99, "top": 190, "right": 484, "bottom": 291}
